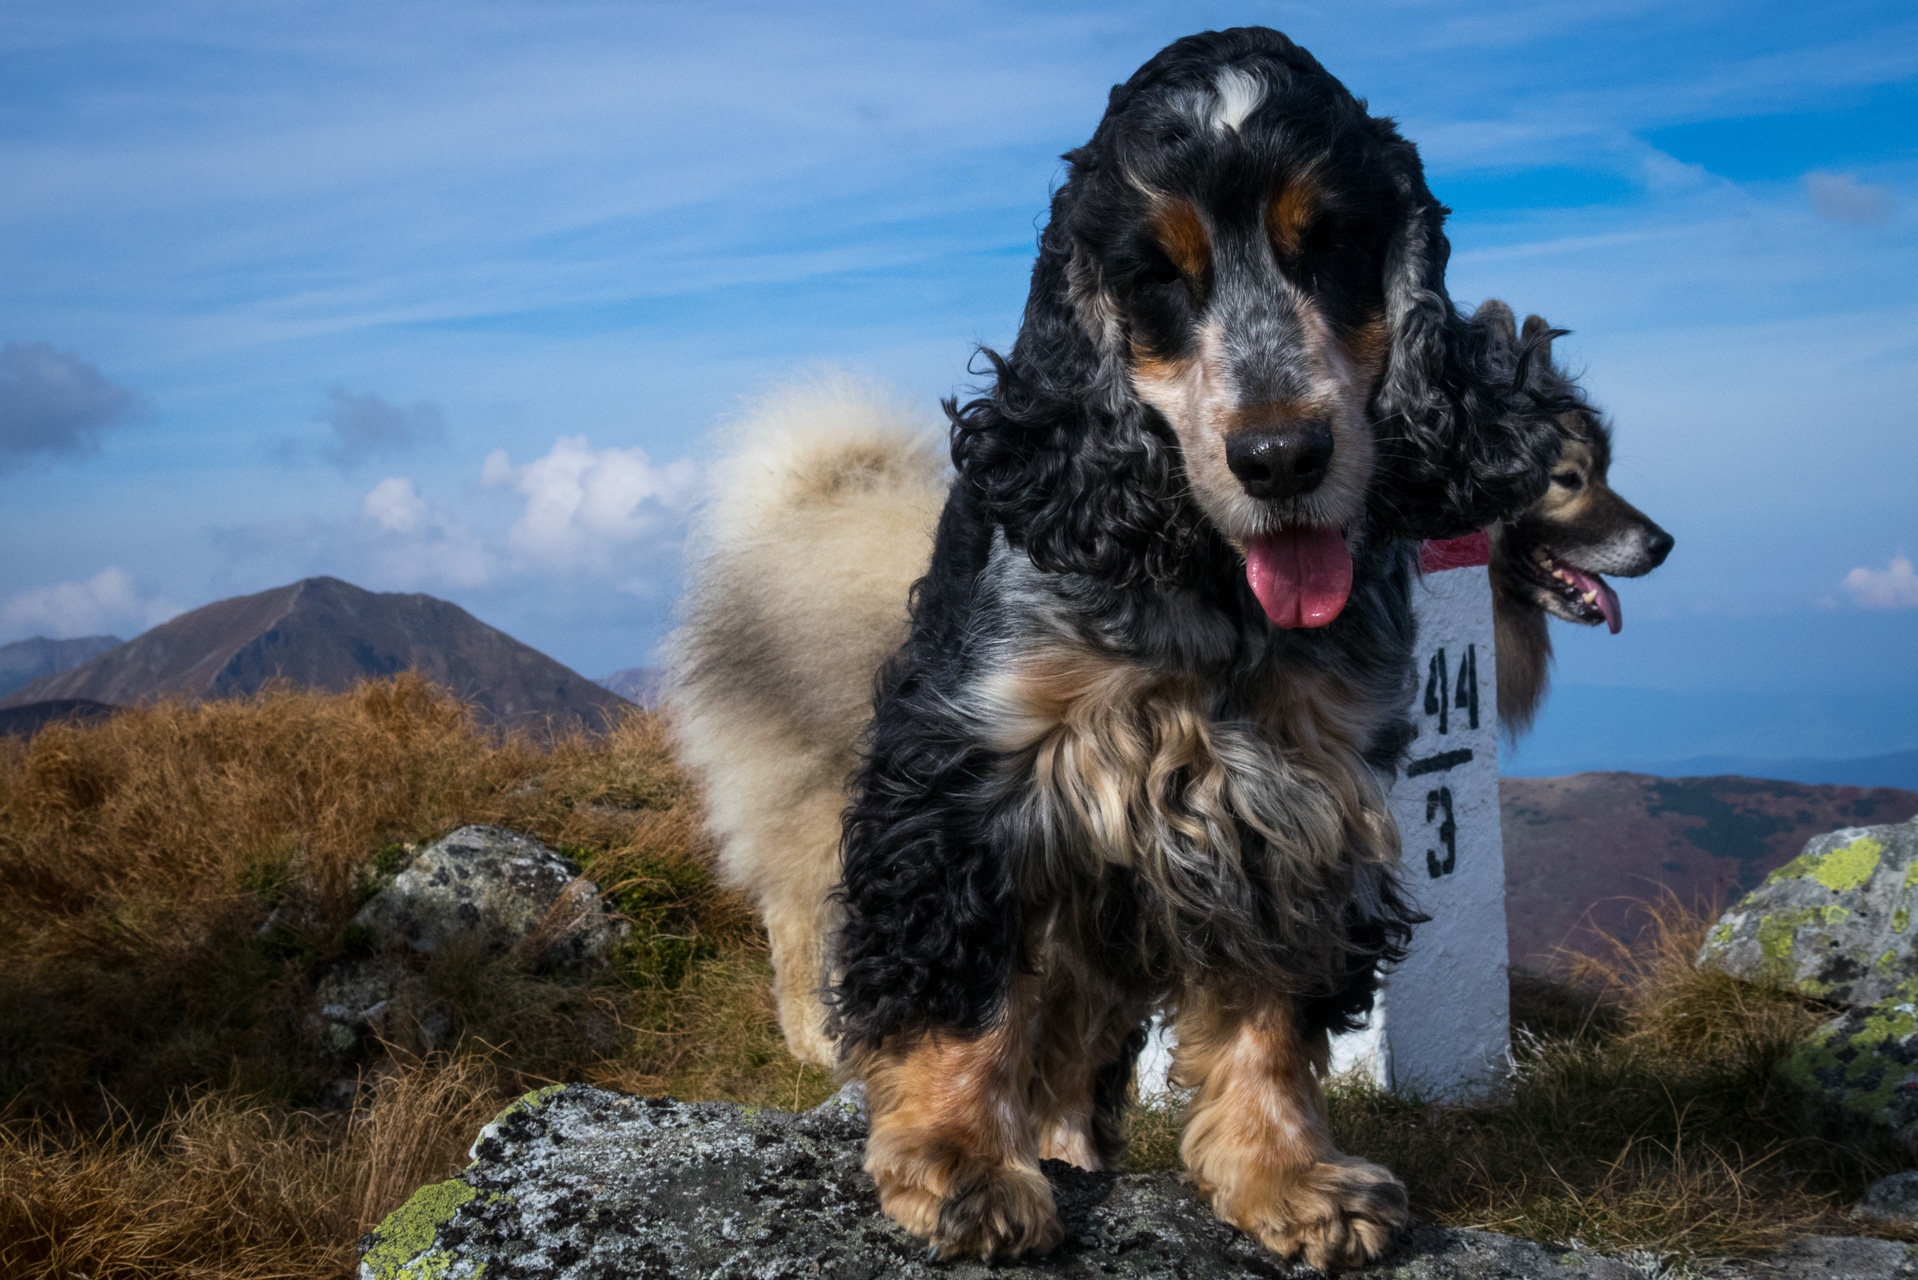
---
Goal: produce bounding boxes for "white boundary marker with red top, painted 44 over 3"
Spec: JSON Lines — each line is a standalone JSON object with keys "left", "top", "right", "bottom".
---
{"left": 1139, "top": 533, "right": 1511, "bottom": 1100}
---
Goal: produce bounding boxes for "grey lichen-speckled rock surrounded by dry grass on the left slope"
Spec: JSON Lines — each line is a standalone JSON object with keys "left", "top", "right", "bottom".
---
{"left": 351, "top": 827, "right": 627, "bottom": 965}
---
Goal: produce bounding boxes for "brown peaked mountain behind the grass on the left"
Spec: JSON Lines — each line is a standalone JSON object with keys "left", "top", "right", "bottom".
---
{"left": 0, "top": 578, "right": 631, "bottom": 727}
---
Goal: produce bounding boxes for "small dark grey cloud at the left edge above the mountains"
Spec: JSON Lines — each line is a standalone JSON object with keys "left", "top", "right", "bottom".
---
{"left": 0, "top": 342, "right": 140, "bottom": 470}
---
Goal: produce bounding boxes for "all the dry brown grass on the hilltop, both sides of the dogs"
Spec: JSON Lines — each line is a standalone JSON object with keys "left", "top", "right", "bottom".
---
{"left": 0, "top": 677, "right": 1901, "bottom": 1280}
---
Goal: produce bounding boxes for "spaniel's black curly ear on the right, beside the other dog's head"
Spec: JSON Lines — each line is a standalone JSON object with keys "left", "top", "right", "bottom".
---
{"left": 1371, "top": 151, "right": 1561, "bottom": 537}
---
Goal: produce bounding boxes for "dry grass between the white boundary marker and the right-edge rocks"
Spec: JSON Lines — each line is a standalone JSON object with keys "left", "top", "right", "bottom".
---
{"left": 1134, "top": 904, "right": 1906, "bottom": 1255}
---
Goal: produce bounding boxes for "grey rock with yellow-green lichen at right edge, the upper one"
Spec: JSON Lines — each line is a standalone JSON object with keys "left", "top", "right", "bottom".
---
{"left": 1697, "top": 819, "right": 1918, "bottom": 1007}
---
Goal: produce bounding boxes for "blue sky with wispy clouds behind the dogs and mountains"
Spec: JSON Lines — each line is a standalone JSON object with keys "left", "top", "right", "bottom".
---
{"left": 0, "top": 0, "right": 1918, "bottom": 768}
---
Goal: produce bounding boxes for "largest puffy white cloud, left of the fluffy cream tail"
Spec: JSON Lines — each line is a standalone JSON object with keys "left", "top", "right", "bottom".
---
{"left": 481, "top": 436, "right": 698, "bottom": 568}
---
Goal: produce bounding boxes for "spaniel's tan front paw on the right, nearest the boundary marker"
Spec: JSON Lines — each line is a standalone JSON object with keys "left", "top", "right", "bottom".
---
{"left": 1212, "top": 1155, "right": 1412, "bottom": 1270}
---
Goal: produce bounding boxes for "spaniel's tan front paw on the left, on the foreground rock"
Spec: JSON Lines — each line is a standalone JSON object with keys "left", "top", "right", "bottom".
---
{"left": 873, "top": 1161, "right": 1064, "bottom": 1263}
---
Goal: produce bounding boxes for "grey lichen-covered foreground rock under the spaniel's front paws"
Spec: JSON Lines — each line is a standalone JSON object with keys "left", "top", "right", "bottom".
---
{"left": 361, "top": 1084, "right": 1887, "bottom": 1280}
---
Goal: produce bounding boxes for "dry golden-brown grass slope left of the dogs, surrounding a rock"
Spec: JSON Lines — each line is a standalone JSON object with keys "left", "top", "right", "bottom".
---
{"left": 0, "top": 677, "right": 786, "bottom": 1280}
